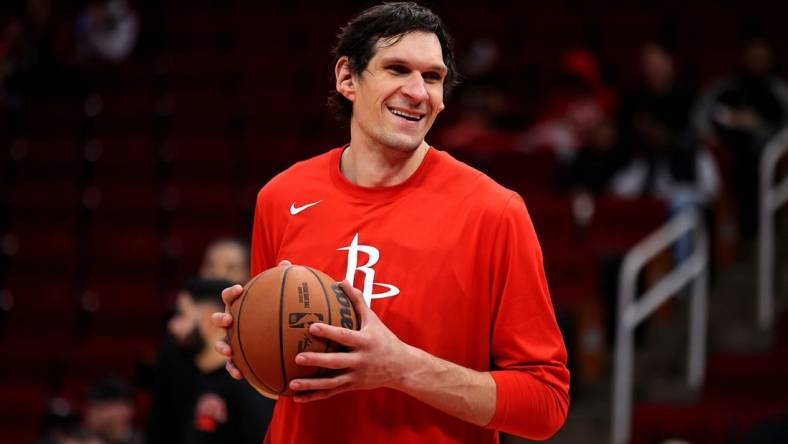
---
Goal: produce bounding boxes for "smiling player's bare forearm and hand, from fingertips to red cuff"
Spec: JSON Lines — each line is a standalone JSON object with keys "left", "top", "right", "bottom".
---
{"left": 290, "top": 281, "right": 496, "bottom": 426}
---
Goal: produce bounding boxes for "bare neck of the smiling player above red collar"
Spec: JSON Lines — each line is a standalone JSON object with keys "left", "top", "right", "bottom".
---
{"left": 340, "top": 140, "right": 429, "bottom": 187}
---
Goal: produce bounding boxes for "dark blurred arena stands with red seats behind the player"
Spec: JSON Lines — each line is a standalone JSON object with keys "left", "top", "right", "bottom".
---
{"left": 0, "top": 0, "right": 788, "bottom": 443}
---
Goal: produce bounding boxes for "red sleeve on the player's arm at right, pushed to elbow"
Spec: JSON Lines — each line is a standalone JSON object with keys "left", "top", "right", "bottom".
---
{"left": 488, "top": 195, "right": 569, "bottom": 439}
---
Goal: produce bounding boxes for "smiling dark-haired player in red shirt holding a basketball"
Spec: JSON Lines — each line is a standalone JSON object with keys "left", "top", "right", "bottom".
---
{"left": 213, "top": 3, "right": 569, "bottom": 443}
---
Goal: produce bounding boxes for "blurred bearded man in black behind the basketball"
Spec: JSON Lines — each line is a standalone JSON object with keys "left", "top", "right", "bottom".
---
{"left": 148, "top": 278, "right": 273, "bottom": 444}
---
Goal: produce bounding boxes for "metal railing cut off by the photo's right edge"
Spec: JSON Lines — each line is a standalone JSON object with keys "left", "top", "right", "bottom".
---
{"left": 757, "top": 128, "right": 788, "bottom": 330}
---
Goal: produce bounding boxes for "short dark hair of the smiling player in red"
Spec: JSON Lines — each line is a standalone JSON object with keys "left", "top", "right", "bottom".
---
{"left": 328, "top": 2, "right": 458, "bottom": 122}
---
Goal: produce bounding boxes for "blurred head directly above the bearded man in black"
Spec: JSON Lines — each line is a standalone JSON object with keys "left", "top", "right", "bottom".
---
{"left": 200, "top": 237, "right": 249, "bottom": 285}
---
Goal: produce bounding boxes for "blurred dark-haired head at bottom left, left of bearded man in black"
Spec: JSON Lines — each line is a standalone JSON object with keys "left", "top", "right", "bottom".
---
{"left": 83, "top": 378, "right": 143, "bottom": 444}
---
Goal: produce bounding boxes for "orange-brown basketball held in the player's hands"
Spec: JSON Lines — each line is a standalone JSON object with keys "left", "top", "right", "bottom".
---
{"left": 229, "top": 265, "right": 361, "bottom": 398}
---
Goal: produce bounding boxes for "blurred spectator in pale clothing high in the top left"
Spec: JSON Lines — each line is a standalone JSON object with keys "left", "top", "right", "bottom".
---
{"left": 74, "top": 0, "right": 139, "bottom": 63}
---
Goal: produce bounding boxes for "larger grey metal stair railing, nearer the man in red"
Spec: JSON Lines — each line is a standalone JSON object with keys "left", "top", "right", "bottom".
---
{"left": 611, "top": 209, "right": 709, "bottom": 444}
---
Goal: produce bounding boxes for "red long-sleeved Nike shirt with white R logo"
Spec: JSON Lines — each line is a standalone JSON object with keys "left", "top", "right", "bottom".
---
{"left": 252, "top": 148, "right": 569, "bottom": 444}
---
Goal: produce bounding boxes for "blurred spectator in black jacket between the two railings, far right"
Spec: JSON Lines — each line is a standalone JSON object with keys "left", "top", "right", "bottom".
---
{"left": 692, "top": 38, "right": 788, "bottom": 239}
